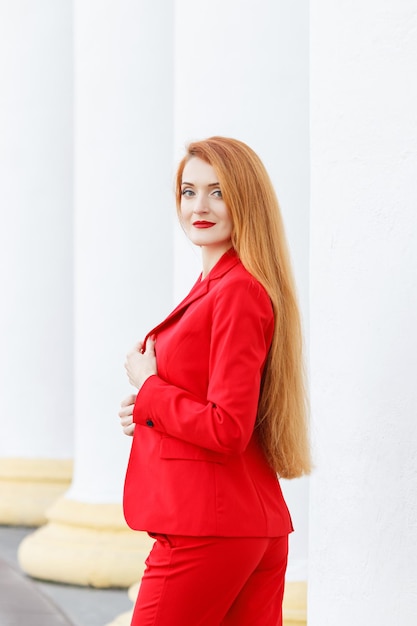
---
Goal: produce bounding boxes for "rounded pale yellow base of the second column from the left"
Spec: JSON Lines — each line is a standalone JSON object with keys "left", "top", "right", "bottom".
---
{"left": 18, "top": 498, "right": 153, "bottom": 588}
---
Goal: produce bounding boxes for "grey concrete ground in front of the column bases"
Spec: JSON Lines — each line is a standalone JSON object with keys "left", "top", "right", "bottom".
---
{"left": 0, "top": 526, "right": 132, "bottom": 626}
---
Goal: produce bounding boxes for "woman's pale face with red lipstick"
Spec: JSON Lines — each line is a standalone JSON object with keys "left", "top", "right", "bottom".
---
{"left": 180, "top": 157, "right": 233, "bottom": 255}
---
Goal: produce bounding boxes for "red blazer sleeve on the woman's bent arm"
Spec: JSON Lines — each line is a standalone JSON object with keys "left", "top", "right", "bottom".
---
{"left": 133, "top": 280, "right": 274, "bottom": 454}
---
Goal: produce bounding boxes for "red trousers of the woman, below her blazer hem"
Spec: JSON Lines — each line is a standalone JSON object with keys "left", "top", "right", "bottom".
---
{"left": 131, "top": 534, "right": 288, "bottom": 626}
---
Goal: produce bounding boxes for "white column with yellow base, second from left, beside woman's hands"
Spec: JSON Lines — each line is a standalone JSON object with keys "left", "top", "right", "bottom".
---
{"left": 18, "top": 0, "right": 175, "bottom": 586}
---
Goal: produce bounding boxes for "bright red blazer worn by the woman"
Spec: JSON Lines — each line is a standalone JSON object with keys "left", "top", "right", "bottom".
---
{"left": 124, "top": 250, "right": 292, "bottom": 537}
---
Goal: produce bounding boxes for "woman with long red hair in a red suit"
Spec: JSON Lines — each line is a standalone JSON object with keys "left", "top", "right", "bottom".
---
{"left": 119, "top": 137, "right": 310, "bottom": 626}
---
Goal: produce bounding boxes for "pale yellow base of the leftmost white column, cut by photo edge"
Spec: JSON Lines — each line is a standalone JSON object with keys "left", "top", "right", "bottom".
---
{"left": 0, "top": 458, "right": 72, "bottom": 526}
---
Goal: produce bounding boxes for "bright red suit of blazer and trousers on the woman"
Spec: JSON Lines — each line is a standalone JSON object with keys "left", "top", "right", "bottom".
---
{"left": 124, "top": 250, "right": 292, "bottom": 626}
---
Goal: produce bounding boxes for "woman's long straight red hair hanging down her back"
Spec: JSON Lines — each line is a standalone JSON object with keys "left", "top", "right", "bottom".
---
{"left": 176, "top": 137, "right": 311, "bottom": 478}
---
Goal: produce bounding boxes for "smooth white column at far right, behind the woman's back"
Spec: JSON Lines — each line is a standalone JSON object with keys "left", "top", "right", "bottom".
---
{"left": 308, "top": 0, "right": 417, "bottom": 626}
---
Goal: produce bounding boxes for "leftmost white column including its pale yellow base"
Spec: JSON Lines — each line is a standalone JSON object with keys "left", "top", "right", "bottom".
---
{"left": 0, "top": 0, "right": 73, "bottom": 525}
